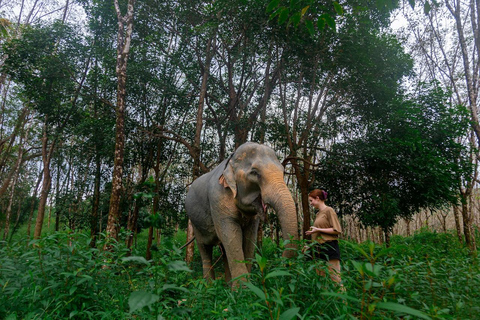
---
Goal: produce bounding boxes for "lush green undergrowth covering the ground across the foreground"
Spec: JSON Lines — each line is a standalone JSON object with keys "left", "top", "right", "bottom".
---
{"left": 0, "top": 231, "right": 480, "bottom": 319}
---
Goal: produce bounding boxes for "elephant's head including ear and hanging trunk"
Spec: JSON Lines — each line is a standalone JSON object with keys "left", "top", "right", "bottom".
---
{"left": 219, "top": 143, "right": 298, "bottom": 257}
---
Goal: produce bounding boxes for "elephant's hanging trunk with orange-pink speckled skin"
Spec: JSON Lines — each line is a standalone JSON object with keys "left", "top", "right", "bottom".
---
{"left": 262, "top": 177, "right": 298, "bottom": 258}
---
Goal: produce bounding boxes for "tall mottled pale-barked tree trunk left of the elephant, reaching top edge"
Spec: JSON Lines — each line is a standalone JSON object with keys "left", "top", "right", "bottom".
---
{"left": 104, "top": 0, "right": 135, "bottom": 249}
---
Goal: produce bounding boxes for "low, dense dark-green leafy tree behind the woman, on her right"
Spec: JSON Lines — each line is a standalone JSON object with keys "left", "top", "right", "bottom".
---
{"left": 318, "top": 86, "right": 472, "bottom": 241}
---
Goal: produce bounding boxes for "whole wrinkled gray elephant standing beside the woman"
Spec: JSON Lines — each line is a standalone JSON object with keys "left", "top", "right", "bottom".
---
{"left": 185, "top": 143, "right": 298, "bottom": 282}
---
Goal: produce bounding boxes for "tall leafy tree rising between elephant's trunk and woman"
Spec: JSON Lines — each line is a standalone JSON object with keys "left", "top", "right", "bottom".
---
{"left": 270, "top": 0, "right": 411, "bottom": 238}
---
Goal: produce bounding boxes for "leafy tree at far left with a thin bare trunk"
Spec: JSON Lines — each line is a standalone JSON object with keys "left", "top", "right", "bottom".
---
{"left": 2, "top": 23, "right": 90, "bottom": 238}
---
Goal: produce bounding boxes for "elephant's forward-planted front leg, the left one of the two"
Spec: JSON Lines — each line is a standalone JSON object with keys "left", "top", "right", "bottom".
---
{"left": 217, "top": 217, "right": 248, "bottom": 280}
